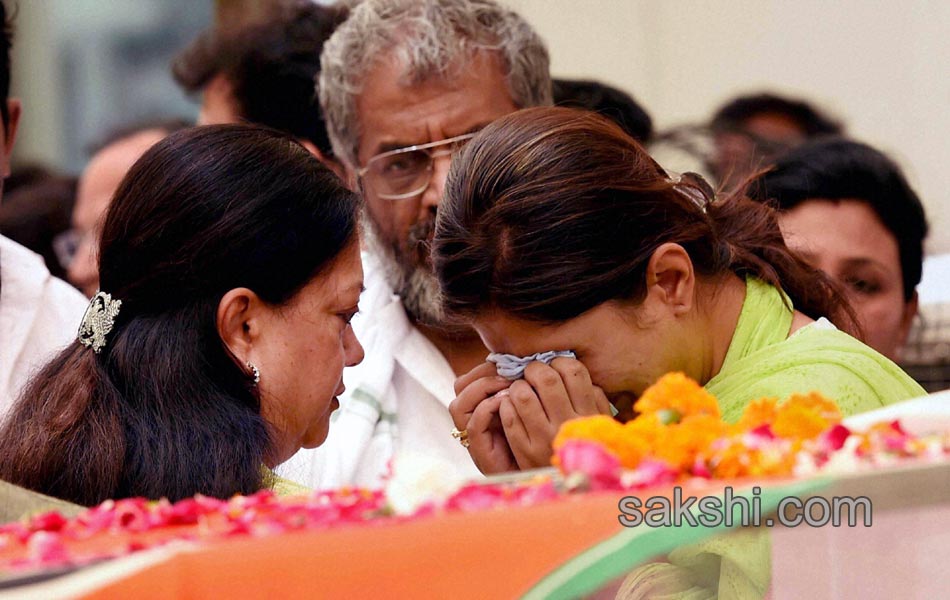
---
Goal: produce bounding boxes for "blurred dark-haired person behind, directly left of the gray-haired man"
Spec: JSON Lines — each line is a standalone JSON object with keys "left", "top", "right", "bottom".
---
{"left": 172, "top": 0, "right": 347, "bottom": 175}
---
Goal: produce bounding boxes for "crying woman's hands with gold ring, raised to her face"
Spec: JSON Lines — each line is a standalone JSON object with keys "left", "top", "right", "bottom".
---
{"left": 449, "top": 358, "right": 611, "bottom": 474}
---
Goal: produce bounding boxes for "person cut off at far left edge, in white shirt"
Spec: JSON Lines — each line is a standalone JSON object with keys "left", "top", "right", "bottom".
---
{"left": 0, "top": 0, "right": 86, "bottom": 421}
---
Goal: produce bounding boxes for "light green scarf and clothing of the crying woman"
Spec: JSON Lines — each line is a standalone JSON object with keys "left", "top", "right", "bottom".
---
{"left": 617, "top": 277, "right": 926, "bottom": 600}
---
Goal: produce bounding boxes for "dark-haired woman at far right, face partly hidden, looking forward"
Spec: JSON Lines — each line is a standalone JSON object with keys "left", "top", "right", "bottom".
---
{"left": 750, "top": 138, "right": 927, "bottom": 360}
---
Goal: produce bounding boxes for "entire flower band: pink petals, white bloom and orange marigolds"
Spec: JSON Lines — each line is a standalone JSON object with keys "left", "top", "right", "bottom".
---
{"left": 0, "top": 373, "right": 950, "bottom": 572}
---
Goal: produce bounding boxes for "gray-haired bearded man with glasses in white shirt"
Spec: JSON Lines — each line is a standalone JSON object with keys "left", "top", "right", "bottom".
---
{"left": 283, "top": 0, "right": 551, "bottom": 489}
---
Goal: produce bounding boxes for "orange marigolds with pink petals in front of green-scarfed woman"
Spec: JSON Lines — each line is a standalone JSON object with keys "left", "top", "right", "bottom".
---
{"left": 554, "top": 373, "right": 950, "bottom": 488}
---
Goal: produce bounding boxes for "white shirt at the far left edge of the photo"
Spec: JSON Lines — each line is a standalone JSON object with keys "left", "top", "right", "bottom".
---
{"left": 0, "top": 236, "right": 89, "bottom": 420}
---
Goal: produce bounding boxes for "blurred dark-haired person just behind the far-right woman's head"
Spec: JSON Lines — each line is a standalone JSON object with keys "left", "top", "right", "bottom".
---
{"left": 709, "top": 93, "right": 843, "bottom": 188}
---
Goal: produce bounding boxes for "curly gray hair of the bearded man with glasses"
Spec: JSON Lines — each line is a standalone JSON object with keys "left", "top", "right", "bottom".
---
{"left": 317, "top": 0, "right": 551, "bottom": 168}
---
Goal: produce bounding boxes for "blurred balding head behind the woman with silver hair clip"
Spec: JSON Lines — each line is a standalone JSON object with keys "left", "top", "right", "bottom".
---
{"left": 62, "top": 121, "right": 185, "bottom": 298}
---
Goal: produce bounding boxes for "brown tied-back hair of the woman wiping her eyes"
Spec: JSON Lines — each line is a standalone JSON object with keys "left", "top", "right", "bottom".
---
{"left": 433, "top": 108, "right": 853, "bottom": 332}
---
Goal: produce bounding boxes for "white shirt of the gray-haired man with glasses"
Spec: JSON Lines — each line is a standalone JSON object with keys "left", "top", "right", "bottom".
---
{"left": 278, "top": 253, "right": 482, "bottom": 490}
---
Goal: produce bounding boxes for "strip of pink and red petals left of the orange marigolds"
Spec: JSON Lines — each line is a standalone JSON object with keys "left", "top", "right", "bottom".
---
{"left": 0, "top": 475, "right": 558, "bottom": 573}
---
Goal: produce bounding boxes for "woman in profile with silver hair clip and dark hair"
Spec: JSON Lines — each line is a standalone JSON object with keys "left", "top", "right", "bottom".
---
{"left": 0, "top": 125, "right": 363, "bottom": 505}
